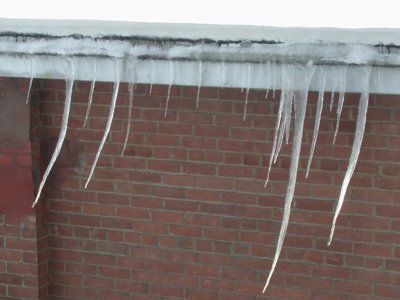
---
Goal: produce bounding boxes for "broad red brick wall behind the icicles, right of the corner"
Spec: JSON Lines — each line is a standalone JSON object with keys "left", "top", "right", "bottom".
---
{"left": 0, "top": 80, "right": 400, "bottom": 300}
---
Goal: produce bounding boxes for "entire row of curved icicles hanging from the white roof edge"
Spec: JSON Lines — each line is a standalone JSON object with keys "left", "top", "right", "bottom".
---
{"left": 27, "top": 59, "right": 370, "bottom": 292}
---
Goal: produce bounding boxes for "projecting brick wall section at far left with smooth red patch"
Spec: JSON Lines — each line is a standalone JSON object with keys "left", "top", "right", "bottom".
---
{"left": 0, "top": 78, "right": 48, "bottom": 299}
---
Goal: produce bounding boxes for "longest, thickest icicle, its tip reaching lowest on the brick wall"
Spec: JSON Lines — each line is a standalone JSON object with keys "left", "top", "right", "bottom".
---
{"left": 262, "top": 66, "right": 314, "bottom": 293}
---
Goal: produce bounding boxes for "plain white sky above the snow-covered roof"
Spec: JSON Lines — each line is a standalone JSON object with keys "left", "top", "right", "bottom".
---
{"left": 0, "top": 0, "right": 400, "bottom": 28}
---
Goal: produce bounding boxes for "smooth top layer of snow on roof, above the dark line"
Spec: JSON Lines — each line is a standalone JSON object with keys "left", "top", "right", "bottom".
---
{"left": 0, "top": 19, "right": 400, "bottom": 45}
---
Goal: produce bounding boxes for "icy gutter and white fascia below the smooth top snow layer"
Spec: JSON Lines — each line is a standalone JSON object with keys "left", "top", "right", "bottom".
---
{"left": 0, "top": 31, "right": 400, "bottom": 94}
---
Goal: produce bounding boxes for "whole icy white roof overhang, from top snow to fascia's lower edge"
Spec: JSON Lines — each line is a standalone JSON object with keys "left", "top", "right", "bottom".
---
{"left": 0, "top": 19, "right": 400, "bottom": 94}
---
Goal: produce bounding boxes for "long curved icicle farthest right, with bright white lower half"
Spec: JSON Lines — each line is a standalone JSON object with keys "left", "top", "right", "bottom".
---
{"left": 328, "top": 69, "right": 371, "bottom": 246}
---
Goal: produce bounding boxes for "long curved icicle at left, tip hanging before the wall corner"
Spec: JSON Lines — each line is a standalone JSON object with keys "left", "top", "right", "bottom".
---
{"left": 32, "top": 59, "right": 75, "bottom": 207}
